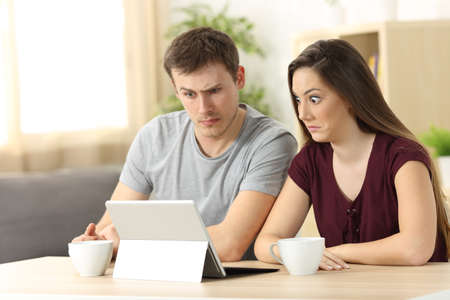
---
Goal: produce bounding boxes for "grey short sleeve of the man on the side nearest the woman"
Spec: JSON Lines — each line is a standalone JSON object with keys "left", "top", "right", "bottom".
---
{"left": 239, "top": 132, "right": 297, "bottom": 197}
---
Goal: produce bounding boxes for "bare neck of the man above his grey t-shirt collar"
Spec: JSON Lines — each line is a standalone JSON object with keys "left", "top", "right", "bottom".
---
{"left": 196, "top": 107, "right": 246, "bottom": 157}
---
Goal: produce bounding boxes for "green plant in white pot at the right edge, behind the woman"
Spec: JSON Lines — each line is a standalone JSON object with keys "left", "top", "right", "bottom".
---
{"left": 420, "top": 126, "right": 450, "bottom": 188}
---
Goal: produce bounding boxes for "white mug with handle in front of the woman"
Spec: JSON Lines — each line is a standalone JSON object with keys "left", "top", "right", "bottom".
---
{"left": 270, "top": 237, "right": 325, "bottom": 275}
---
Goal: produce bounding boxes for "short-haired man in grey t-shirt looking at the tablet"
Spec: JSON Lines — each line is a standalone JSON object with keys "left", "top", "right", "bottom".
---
{"left": 74, "top": 28, "right": 297, "bottom": 261}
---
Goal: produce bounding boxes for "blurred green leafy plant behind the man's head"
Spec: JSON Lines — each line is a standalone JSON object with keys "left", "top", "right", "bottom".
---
{"left": 160, "top": 4, "right": 271, "bottom": 116}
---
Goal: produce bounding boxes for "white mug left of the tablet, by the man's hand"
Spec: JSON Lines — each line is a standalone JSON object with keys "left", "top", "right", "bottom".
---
{"left": 68, "top": 240, "right": 113, "bottom": 276}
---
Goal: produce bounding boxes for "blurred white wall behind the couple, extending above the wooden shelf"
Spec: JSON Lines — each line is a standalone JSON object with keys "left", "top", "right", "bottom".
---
{"left": 169, "top": 0, "right": 450, "bottom": 132}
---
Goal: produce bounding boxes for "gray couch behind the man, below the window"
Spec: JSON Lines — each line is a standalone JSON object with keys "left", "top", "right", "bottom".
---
{"left": 0, "top": 166, "right": 120, "bottom": 263}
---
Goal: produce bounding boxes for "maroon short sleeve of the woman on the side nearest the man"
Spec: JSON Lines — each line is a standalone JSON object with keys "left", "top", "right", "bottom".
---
{"left": 288, "top": 146, "right": 312, "bottom": 197}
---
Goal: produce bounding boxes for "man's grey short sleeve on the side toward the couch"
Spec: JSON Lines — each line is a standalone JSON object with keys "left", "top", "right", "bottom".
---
{"left": 120, "top": 127, "right": 153, "bottom": 195}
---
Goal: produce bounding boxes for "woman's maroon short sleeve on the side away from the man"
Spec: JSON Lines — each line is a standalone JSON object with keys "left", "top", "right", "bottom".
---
{"left": 391, "top": 139, "right": 431, "bottom": 178}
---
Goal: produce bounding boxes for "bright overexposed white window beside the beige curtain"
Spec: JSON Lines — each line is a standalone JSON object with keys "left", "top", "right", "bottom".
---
{"left": 11, "top": 0, "right": 127, "bottom": 133}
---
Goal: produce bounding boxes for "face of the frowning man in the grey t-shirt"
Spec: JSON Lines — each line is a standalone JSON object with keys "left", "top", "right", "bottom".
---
{"left": 172, "top": 63, "right": 245, "bottom": 138}
